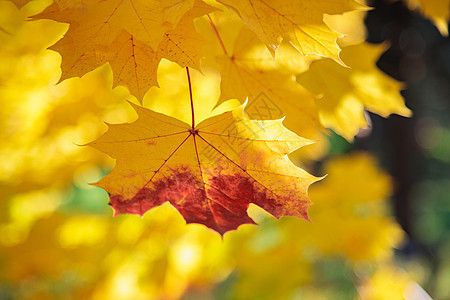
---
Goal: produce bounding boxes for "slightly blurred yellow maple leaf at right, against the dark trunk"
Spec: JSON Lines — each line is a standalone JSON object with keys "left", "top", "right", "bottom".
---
{"left": 297, "top": 44, "right": 411, "bottom": 141}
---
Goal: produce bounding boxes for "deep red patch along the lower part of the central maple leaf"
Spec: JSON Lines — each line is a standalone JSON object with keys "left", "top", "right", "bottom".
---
{"left": 110, "top": 169, "right": 307, "bottom": 235}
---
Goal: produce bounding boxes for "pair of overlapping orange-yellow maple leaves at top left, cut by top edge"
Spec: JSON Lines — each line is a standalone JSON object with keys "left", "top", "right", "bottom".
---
{"left": 35, "top": 0, "right": 211, "bottom": 100}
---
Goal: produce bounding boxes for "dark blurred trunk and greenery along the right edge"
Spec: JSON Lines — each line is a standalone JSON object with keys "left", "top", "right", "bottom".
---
{"left": 354, "top": 0, "right": 450, "bottom": 295}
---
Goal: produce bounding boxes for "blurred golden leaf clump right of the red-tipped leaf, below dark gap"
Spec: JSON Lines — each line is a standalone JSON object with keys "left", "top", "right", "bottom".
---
{"left": 306, "top": 153, "right": 403, "bottom": 261}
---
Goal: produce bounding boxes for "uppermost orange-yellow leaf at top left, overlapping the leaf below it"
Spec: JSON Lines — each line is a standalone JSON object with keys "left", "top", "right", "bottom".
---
{"left": 39, "top": 0, "right": 194, "bottom": 49}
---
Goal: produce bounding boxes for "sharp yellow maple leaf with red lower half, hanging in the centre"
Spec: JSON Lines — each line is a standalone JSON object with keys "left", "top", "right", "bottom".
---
{"left": 90, "top": 105, "right": 317, "bottom": 234}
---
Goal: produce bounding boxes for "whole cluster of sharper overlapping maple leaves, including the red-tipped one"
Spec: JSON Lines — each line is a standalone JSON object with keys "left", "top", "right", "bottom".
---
{"left": 9, "top": 0, "right": 418, "bottom": 234}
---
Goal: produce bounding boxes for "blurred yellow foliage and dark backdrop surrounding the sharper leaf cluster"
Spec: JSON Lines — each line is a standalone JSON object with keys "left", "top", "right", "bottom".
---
{"left": 0, "top": 0, "right": 450, "bottom": 300}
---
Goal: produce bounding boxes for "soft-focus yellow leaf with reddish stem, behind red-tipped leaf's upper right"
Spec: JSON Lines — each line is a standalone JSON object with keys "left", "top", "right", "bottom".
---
{"left": 196, "top": 11, "right": 326, "bottom": 161}
